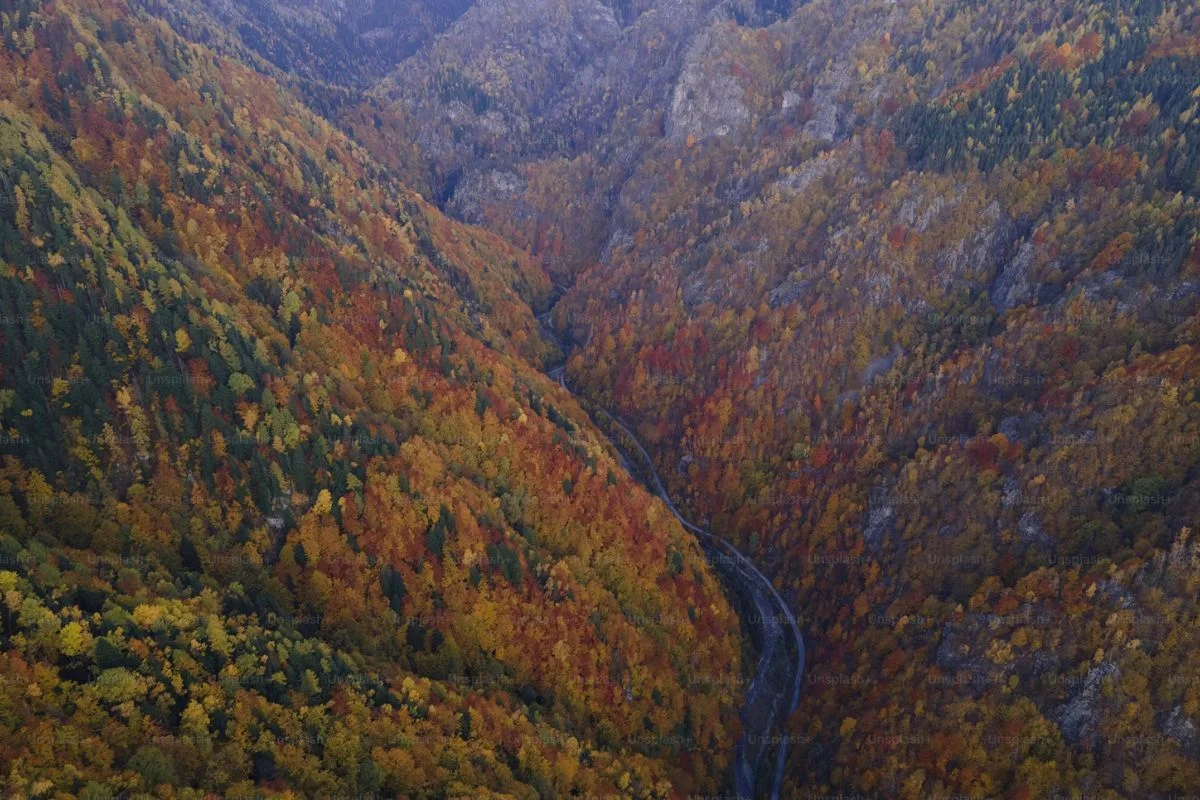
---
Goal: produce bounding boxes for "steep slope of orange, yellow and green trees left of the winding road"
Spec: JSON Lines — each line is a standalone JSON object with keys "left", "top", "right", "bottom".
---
{"left": 0, "top": 0, "right": 740, "bottom": 798}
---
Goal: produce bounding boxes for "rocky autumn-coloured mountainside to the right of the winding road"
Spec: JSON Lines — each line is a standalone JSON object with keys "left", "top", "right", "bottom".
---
{"left": 383, "top": 0, "right": 1200, "bottom": 798}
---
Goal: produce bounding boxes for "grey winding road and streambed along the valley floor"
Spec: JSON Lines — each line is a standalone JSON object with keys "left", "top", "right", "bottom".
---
{"left": 538, "top": 312, "right": 805, "bottom": 800}
